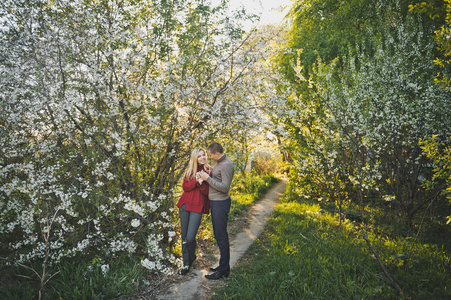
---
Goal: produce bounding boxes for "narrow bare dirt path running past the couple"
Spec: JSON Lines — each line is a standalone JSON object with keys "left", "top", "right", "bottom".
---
{"left": 157, "top": 180, "right": 286, "bottom": 300}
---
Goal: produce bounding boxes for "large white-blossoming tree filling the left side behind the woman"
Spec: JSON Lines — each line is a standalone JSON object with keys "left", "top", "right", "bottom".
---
{"left": 0, "top": 0, "right": 276, "bottom": 284}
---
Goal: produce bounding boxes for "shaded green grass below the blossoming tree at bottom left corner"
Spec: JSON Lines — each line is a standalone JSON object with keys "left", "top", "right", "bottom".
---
{"left": 0, "top": 256, "right": 146, "bottom": 299}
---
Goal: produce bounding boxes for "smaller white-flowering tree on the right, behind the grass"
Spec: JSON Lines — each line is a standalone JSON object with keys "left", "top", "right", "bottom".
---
{"left": 320, "top": 14, "right": 451, "bottom": 224}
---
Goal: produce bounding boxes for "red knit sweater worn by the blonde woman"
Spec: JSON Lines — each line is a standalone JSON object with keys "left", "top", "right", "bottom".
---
{"left": 177, "top": 167, "right": 210, "bottom": 215}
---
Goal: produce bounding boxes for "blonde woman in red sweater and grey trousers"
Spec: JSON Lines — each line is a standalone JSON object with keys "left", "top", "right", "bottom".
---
{"left": 177, "top": 148, "right": 211, "bottom": 275}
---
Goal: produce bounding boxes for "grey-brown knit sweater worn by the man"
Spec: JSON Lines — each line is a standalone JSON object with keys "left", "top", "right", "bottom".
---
{"left": 207, "top": 154, "right": 235, "bottom": 201}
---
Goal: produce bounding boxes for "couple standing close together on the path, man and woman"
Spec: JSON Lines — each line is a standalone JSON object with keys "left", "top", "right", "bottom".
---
{"left": 177, "top": 143, "right": 234, "bottom": 280}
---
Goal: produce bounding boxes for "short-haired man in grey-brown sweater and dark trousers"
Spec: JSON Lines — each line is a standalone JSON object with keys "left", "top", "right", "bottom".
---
{"left": 200, "top": 142, "right": 235, "bottom": 280}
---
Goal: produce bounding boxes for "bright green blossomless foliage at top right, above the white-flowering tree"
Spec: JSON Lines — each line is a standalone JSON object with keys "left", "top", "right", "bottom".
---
{"left": 278, "top": 0, "right": 442, "bottom": 82}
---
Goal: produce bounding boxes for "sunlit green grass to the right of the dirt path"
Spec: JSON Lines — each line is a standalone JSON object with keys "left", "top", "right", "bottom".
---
{"left": 212, "top": 191, "right": 451, "bottom": 299}
